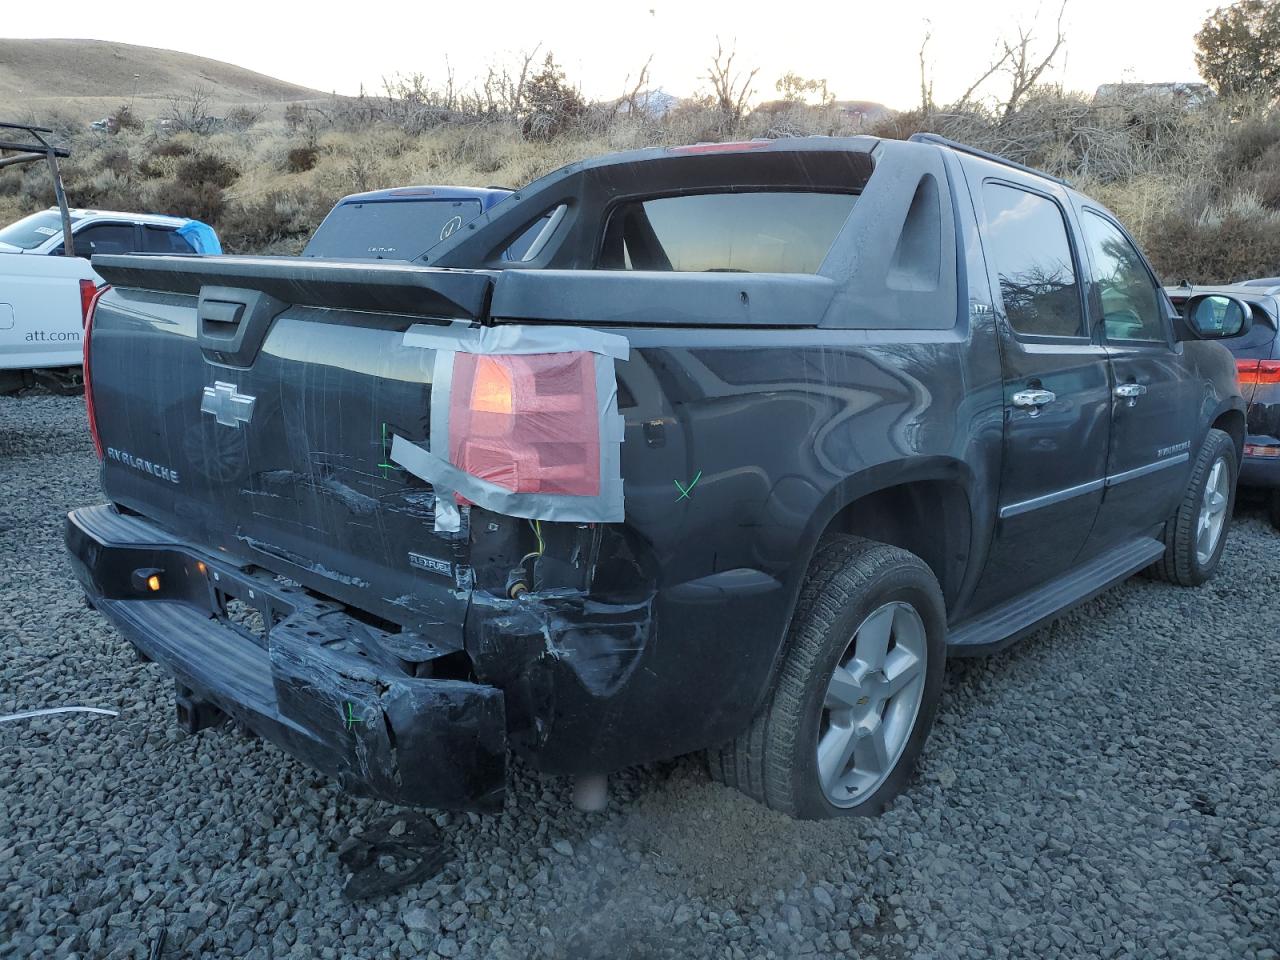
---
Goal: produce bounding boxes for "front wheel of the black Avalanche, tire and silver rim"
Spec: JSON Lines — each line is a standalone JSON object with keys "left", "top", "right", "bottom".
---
{"left": 1151, "top": 430, "right": 1239, "bottom": 586}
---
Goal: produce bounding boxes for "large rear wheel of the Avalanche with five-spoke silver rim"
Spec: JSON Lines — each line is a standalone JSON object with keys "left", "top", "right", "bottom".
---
{"left": 708, "top": 535, "right": 946, "bottom": 819}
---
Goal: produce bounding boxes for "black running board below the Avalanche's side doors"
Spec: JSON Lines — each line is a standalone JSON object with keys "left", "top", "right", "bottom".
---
{"left": 947, "top": 536, "right": 1165, "bottom": 657}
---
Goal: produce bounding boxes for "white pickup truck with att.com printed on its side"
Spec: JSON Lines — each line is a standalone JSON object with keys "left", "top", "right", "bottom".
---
{"left": 0, "top": 207, "right": 221, "bottom": 393}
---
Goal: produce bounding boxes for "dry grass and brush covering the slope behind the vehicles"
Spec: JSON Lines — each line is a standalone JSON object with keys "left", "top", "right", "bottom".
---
{"left": 0, "top": 90, "right": 1280, "bottom": 282}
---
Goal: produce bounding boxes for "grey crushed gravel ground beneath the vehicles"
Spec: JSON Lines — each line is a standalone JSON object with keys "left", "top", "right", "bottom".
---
{"left": 0, "top": 394, "right": 1280, "bottom": 960}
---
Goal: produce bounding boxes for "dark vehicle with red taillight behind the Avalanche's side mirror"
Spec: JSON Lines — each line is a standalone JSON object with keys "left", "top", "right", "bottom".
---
{"left": 1166, "top": 276, "right": 1280, "bottom": 530}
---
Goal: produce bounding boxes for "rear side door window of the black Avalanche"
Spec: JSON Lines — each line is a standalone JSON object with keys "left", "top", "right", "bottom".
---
{"left": 982, "top": 183, "right": 1085, "bottom": 338}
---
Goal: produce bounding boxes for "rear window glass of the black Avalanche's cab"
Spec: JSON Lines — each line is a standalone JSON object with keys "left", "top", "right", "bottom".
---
{"left": 599, "top": 191, "right": 856, "bottom": 274}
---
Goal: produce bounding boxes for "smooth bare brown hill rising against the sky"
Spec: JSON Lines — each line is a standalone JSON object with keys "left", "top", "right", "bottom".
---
{"left": 0, "top": 40, "right": 328, "bottom": 120}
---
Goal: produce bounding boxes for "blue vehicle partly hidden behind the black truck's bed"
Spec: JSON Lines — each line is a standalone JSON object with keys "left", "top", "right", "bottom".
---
{"left": 302, "top": 186, "right": 511, "bottom": 260}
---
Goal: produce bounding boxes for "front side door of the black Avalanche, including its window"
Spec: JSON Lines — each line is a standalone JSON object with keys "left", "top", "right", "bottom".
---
{"left": 1080, "top": 206, "right": 1201, "bottom": 548}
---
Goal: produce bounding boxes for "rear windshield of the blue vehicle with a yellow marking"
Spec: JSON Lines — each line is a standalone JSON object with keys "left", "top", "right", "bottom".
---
{"left": 302, "top": 200, "right": 480, "bottom": 260}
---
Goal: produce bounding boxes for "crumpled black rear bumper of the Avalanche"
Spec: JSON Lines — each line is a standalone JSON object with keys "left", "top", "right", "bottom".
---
{"left": 67, "top": 506, "right": 507, "bottom": 810}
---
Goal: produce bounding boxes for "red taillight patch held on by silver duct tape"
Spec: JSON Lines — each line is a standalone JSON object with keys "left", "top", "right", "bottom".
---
{"left": 449, "top": 352, "right": 600, "bottom": 497}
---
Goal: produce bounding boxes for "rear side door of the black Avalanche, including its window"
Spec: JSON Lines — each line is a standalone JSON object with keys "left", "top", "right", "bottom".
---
{"left": 974, "top": 176, "right": 1111, "bottom": 605}
